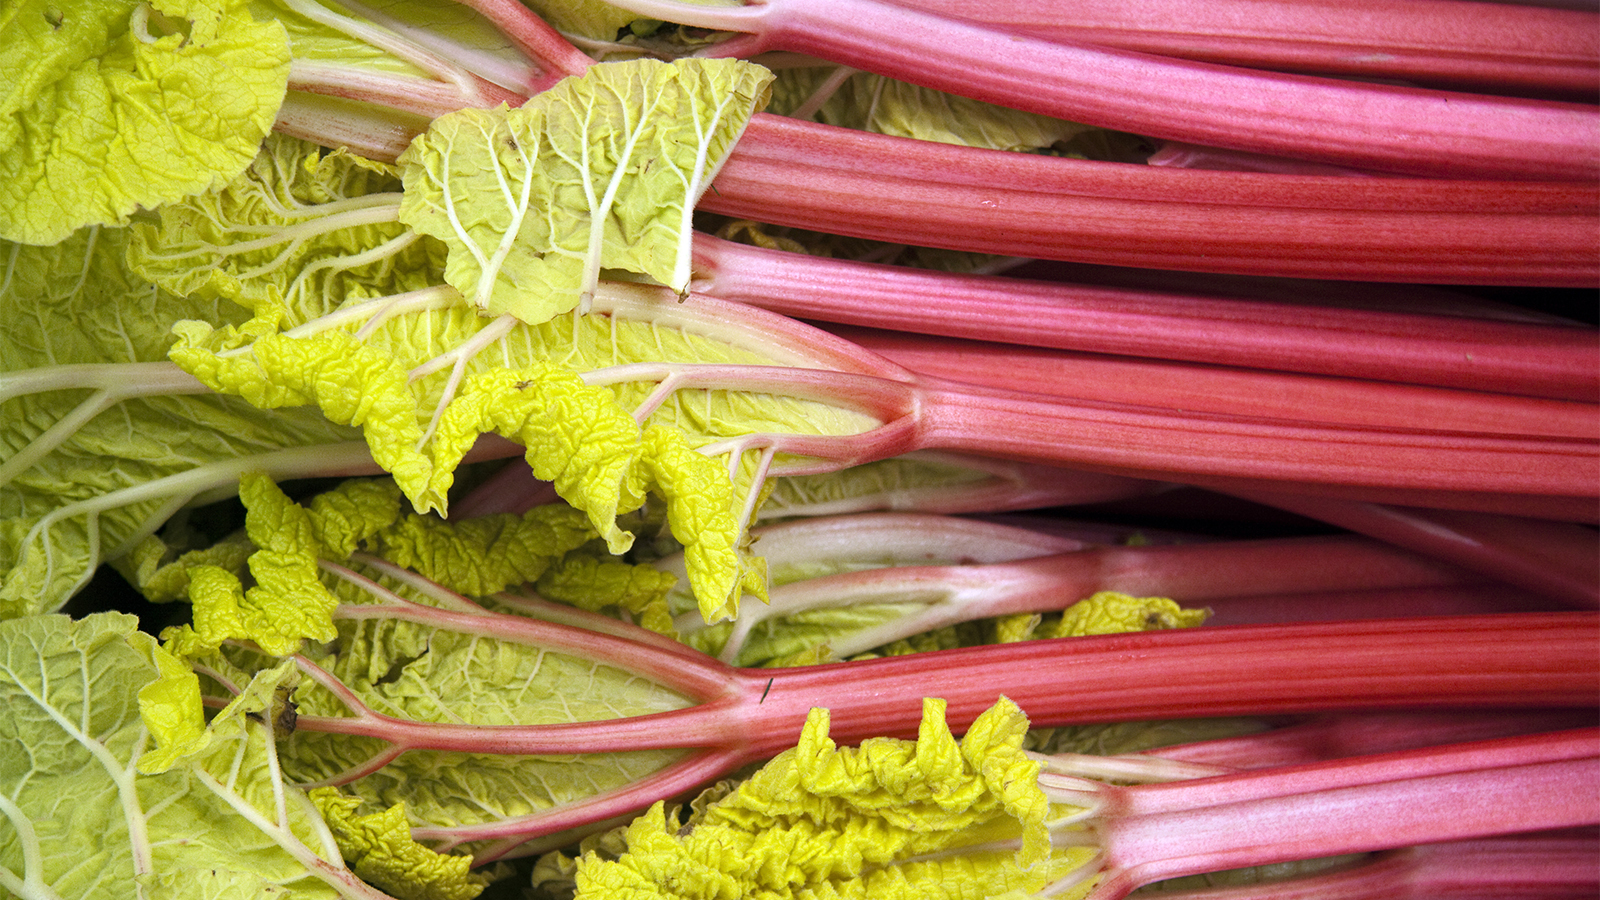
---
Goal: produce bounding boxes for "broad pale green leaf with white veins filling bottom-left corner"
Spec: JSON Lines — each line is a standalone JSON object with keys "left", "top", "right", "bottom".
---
{"left": 0, "top": 613, "right": 358, "bottom": 900}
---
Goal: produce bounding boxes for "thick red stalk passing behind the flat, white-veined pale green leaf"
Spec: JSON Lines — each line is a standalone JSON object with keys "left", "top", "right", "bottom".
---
{"left": 278, "top": 0, "right": 1600, "bottom": 287}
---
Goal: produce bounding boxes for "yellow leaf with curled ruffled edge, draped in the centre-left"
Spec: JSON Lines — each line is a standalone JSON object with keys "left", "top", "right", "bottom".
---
{"left": 171, "top": 285, "right": 875, "bottom": 617}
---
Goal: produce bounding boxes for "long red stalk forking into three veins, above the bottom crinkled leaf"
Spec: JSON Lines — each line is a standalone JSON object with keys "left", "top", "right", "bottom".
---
{"left": 272, "top": 567, "right": 1600, "bottom": 858}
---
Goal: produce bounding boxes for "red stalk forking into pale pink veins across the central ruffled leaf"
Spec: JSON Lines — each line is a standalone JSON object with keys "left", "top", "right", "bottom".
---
{"left": 582, "top": 285, "right": 1600, "bottom": 508}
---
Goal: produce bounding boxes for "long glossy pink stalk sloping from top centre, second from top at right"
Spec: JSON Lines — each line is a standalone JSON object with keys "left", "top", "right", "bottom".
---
{"left": 601, "top": 0, "right": 1600, "bottom": 179}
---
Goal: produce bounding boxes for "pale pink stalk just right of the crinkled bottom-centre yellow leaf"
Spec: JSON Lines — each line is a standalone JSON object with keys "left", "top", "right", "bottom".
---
{"left": 1062, "top": 729, "right": 1600, "bottom": 900}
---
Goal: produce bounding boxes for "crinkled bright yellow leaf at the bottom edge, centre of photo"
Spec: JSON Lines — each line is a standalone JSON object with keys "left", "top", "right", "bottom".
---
{"left": 574, "top": 698, "right": 1093, "bottom": 898}
